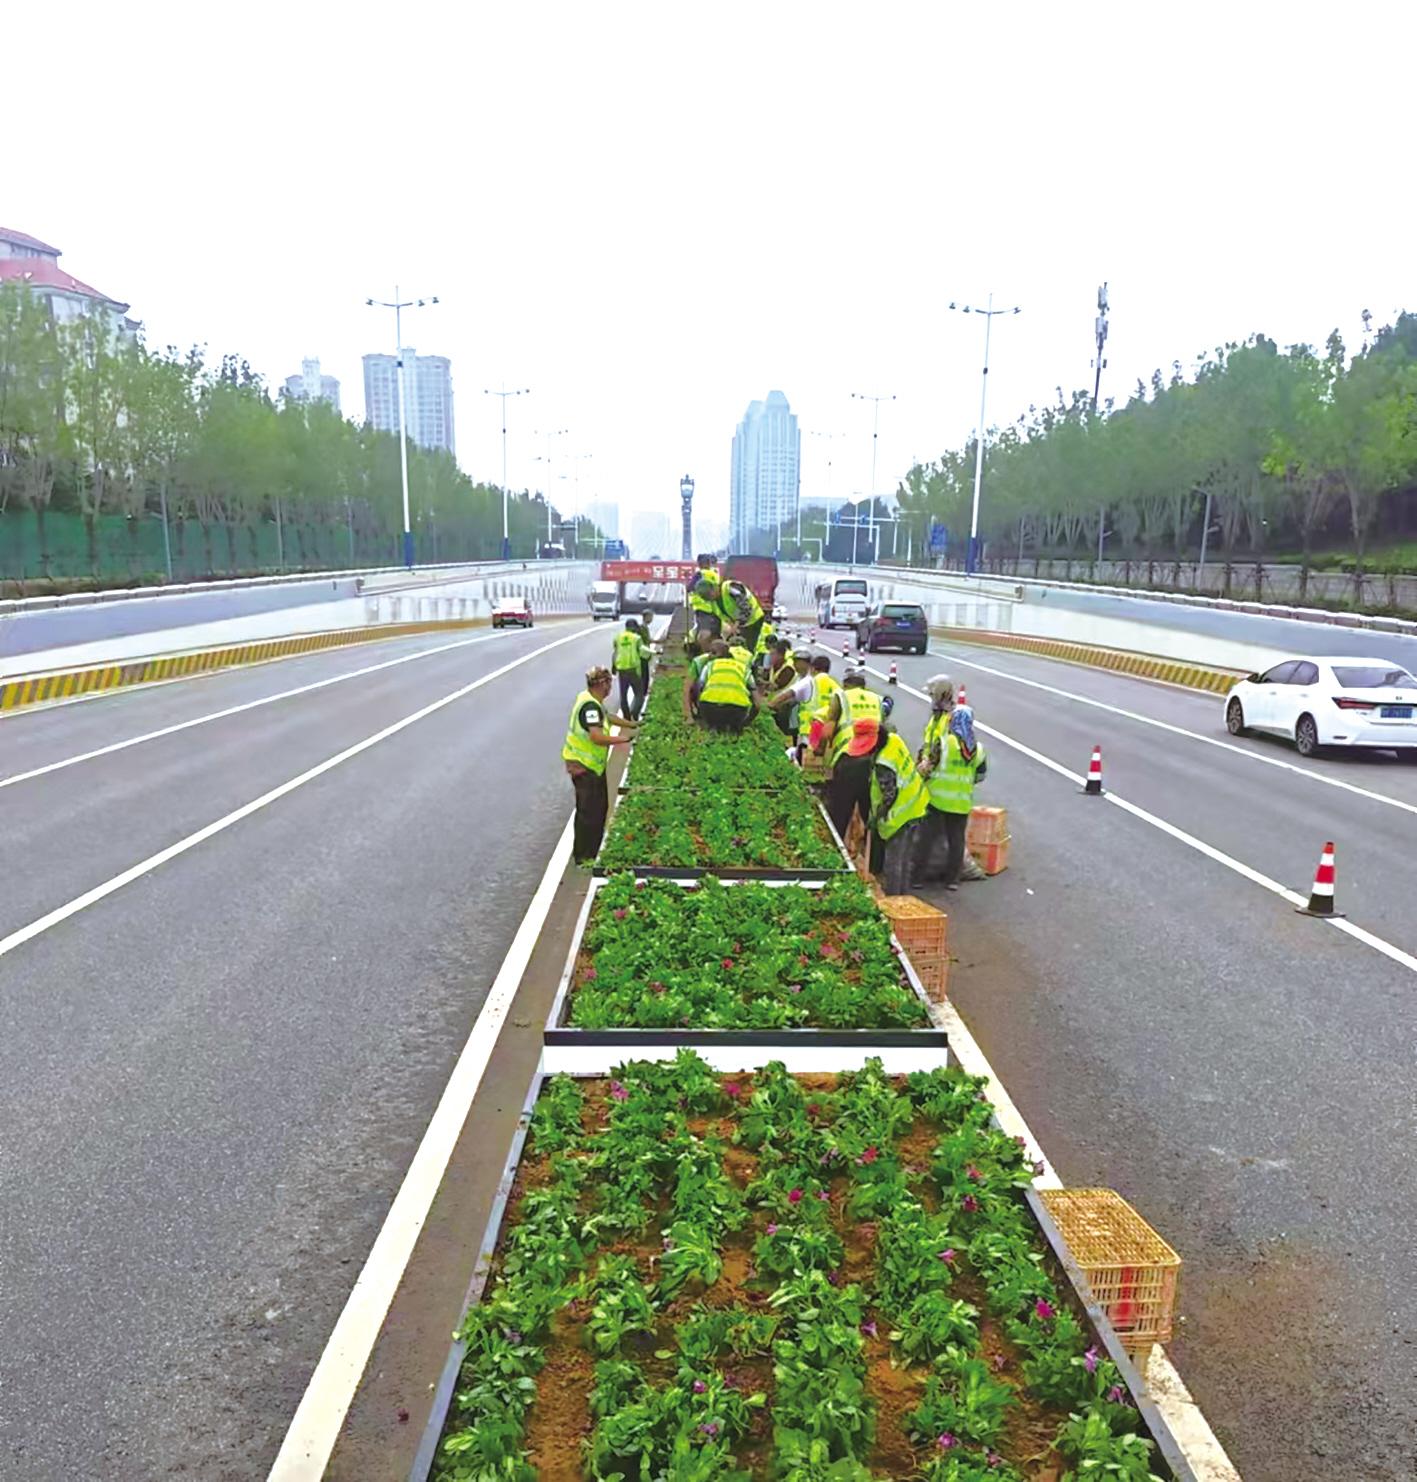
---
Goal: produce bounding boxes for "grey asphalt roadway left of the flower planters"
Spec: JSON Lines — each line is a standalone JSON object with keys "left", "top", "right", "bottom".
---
{"left": 0, "top": 619, "right": 612, "bottom": 1482}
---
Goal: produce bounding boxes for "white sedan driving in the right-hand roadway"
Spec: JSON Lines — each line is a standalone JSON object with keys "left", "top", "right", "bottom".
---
{"left": 1224, "top": 655, "right": 1417, "bottom": 760}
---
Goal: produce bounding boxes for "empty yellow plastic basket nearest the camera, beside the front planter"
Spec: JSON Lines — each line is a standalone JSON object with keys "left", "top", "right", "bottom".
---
{"left": 1038, "top": 1189, "right": 1181, "bottom": 1355}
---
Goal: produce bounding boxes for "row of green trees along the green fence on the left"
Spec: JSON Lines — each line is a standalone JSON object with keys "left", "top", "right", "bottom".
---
{"left": 0, "top": 283, "right": 593, "bottom": 576}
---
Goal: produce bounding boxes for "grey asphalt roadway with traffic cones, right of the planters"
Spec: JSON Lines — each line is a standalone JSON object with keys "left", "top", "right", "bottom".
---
{"left": 800, "top": 634, "right": 1417, "bottom": 1482}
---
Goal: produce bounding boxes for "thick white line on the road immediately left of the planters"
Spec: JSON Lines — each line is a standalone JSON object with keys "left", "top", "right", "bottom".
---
{"left": 270, "top": 818, "right": 575, "bottom": 1482}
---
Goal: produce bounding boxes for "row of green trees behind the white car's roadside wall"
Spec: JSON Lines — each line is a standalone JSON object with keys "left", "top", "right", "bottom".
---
{"left": 898, "top": 314, "right": 1417, "bottom": 571}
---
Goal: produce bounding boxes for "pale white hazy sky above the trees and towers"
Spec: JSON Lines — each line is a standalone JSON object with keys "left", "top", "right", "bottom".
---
{"left": 0, "top": 0, "right": 1417, "bottom": 529}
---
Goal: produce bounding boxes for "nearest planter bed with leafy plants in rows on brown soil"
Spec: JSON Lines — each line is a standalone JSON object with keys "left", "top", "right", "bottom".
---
{"left": 412, "top": 1045, "right": 1193, "bottom": 1482}
